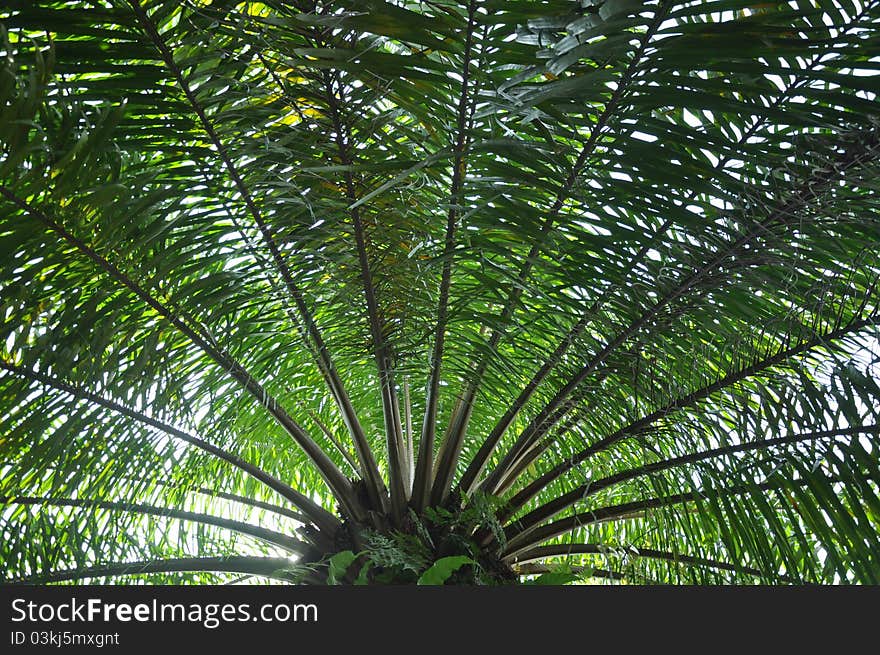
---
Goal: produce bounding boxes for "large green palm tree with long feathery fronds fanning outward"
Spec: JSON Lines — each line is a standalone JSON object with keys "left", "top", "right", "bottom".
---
{"left": 0, "top": 0, "right": 880, "bottom": 584}
